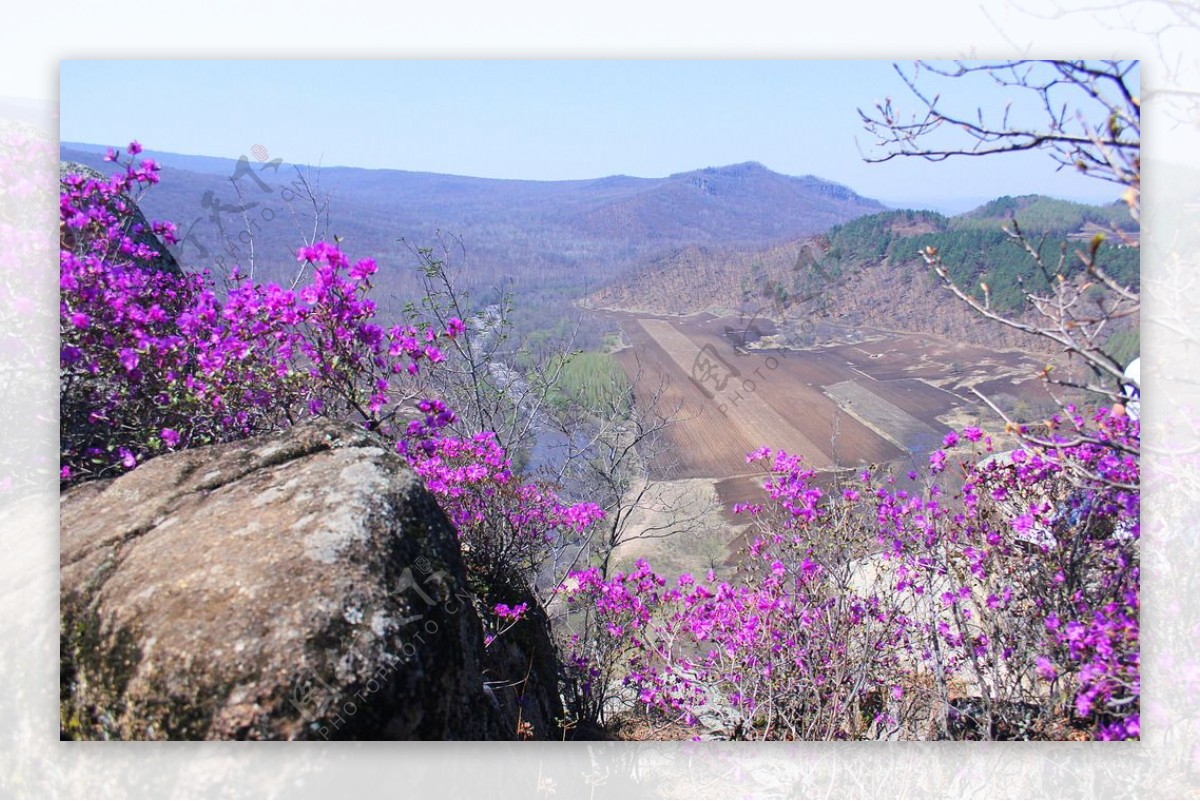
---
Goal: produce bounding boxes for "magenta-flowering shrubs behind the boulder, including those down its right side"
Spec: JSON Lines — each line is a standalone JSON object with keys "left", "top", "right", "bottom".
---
{"left": 60, "top": 149, "right": 602, "bottom": 695}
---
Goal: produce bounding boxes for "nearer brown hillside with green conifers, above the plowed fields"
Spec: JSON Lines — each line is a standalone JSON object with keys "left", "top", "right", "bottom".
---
{"left": 588, "top": 195, "right": 1140, "bottom": 349}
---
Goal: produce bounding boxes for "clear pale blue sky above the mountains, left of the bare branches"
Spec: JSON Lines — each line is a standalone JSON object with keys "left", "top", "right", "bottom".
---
{"left": 60, "top": 60, "right": 1116, "bottom": 204}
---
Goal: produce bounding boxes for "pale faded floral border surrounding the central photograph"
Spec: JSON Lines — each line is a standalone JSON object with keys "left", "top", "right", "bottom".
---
{"left": 0, "top": 0, "right": 1200, "bottom": 799}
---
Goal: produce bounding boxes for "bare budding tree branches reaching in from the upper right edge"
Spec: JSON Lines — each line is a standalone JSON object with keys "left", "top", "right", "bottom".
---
{"left": 859, "top": 60, "right": 1141, "bottom": 455}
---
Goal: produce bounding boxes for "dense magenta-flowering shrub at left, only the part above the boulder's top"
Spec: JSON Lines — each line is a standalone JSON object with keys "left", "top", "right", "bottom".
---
{"left": 60, "top": 143, "right": 462, "bottom": 482}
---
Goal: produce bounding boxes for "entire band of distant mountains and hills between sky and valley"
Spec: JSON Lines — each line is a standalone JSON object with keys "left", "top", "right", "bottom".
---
{"left": 61, "top": 143, "right": 1138, "bottom": 352}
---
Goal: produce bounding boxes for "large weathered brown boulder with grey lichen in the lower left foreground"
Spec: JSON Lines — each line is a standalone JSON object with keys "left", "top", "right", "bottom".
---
{"left": 60, "top": 421, "right": 557, "bottom": 740}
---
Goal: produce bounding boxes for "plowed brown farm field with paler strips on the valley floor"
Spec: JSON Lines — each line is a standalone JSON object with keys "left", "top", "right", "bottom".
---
{"left": 604, "top": 313, "right": 1056, "bottom": 496}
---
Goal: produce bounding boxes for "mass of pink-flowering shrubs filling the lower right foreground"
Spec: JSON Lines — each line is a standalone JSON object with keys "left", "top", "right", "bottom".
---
{"left": 572, "top": 410, "right": 1140, "bottom": 739}
